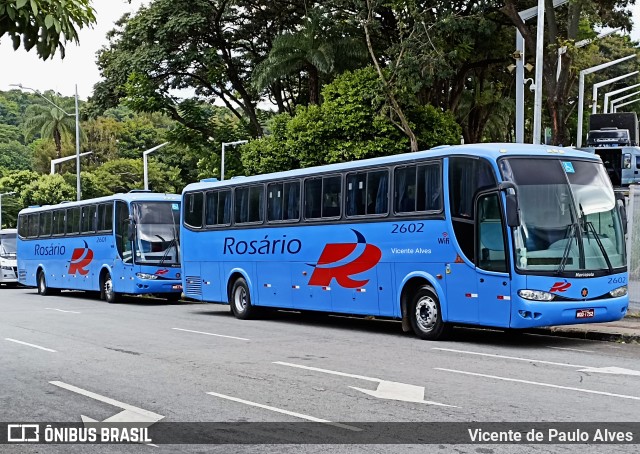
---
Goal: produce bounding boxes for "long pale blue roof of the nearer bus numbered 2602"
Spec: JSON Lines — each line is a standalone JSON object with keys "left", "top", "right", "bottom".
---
{"left": 183, "top": 143, "right": 601, "bottom": 193}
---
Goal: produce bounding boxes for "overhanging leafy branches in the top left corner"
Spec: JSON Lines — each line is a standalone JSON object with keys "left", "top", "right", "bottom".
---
{"left": 0, "top": 0, "right": 96, "bottom": 60}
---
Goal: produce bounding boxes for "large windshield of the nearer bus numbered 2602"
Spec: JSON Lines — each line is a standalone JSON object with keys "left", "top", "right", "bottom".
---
{"left": 500, "top": 158, "right": 626, "bottom": 277}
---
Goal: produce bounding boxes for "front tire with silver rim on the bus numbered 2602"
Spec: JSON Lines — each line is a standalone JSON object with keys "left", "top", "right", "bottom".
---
{"left": 409, "top": 285, "right": 450, "bottom": 340}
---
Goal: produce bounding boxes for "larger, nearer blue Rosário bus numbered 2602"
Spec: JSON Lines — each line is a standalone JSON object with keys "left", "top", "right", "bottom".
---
{"left": 180, "top": 144, "right": 628, "bottom": 339}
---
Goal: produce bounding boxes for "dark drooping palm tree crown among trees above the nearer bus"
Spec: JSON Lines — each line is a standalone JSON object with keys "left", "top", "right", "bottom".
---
{"left": 253, "top": 12, "right": 367, "bottom": 104}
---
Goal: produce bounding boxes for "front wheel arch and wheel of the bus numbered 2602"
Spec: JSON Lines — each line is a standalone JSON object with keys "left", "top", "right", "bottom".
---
{"left": 400, "top": 276, "right": 450, "bottom": 340}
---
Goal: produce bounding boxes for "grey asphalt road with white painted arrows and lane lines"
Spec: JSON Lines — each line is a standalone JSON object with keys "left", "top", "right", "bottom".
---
{"left": 0, "top": 288, "right": 640, "bottom": 454}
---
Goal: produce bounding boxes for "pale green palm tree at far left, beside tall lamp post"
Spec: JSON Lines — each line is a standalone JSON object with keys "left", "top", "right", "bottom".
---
{"left": 24, "top": 96, "right": 76, "bottom": 158}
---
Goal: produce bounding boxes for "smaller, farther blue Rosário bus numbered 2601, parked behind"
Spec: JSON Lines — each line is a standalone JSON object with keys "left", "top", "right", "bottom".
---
{"left": 17, "top": 191, "right": 182, "bottom": 303}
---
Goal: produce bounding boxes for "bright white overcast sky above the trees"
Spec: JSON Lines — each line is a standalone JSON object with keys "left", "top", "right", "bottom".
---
{"left": 0, "top": 0, "right": 640, "bottom": 99}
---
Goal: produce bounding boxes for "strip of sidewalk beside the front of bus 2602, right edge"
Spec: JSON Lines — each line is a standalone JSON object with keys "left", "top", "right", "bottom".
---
{"left": 530, "top": 315, "right": 640, "bottom": 344}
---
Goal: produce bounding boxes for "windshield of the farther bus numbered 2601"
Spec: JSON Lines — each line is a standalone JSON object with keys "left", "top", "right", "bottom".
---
{"left": 132, "top": 202, "right": 180, "bottom": 266}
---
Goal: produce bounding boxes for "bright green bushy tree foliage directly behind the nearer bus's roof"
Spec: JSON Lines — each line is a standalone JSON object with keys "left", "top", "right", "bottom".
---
{"left": 242, "top": 67, "right": 460, "bottom": 174}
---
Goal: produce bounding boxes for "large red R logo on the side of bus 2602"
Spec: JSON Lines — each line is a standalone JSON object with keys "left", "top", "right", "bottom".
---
{"left": 309, "top": 229, "right": 382, "bottom": 288}
